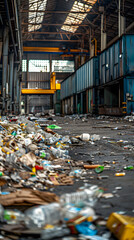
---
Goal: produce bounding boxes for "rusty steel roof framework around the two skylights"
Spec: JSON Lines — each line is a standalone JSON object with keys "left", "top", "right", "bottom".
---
{"left": 20, "top": 0, "right": 134, "bottom": 49}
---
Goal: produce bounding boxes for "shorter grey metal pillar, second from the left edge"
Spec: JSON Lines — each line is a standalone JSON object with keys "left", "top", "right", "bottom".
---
{"left": 9, "top": 53, "right": 14, "bottom": 113}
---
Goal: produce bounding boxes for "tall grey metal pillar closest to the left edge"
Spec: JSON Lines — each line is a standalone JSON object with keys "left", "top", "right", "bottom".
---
{"left": 2, "top": 27, "right": 9, "bottom": 114}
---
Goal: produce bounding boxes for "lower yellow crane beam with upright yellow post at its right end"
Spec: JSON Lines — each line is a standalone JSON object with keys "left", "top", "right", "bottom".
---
{"left": 21, "top": 72, "right": 61, "bottom": 95}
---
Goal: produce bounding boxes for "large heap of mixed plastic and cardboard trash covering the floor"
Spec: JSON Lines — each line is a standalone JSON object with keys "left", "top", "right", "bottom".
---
{"left": 0, "top": 116, "right": 133, "bottom": 240}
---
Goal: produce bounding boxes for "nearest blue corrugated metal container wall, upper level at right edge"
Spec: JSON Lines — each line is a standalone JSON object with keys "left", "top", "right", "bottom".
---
{"left": 99, "top": 35, "right": 134, "bottom": 84}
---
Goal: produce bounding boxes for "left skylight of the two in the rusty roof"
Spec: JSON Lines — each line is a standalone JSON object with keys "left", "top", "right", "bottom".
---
{"left": 28, "top": 0, "right": 47, "bottom": 32}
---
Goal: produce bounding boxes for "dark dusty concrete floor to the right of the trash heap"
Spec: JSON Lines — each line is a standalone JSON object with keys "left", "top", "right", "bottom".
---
{"left": 51, "top": 116, "right": 134, "bottom": 239}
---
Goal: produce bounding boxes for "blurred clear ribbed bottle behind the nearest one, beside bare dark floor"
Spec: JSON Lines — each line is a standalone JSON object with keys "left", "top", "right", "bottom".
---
{"left": 60, "top": 185, "right": 100, "bottom": 207}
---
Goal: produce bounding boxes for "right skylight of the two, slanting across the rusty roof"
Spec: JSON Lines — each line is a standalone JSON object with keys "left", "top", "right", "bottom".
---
{"left": 61, "top": 0, "right": 97, "bottom": 33}
